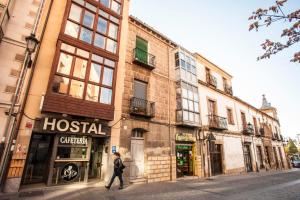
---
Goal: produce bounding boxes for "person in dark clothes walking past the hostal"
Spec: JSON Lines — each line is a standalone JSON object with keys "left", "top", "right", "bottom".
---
{"left": 105, "top": 152, "right": 125, "bottom": 190}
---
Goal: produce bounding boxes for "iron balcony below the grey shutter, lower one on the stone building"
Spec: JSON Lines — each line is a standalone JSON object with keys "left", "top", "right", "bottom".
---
{"left": 130, "top": 97, "right": 155, "bottom": 118}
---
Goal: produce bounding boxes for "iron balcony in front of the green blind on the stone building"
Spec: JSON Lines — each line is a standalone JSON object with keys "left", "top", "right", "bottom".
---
{"left": 133, "top": 48, "right": 156, "bottom": 70}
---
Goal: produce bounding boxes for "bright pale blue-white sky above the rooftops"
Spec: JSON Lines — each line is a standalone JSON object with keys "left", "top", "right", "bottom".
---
{"left": 130, "top": 0, "right": 300, "bottom": 137}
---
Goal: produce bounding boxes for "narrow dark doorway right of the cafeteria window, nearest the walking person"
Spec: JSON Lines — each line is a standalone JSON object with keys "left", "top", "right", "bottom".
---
{"left": 89, "top": 138, "right": 104, "bottom": 179}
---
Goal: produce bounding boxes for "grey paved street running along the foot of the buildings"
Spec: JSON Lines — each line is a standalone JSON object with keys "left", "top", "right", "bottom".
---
{"left": 0, "top": 170, "right": 300, "bottom": 200}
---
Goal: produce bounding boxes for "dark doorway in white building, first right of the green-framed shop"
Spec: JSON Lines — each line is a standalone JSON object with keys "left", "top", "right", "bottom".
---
{"left": 210, "top": 143, "right": 223, "bottom": 176}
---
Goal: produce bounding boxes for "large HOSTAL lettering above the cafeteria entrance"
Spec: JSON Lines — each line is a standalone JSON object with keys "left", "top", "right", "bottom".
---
{"left": 43, "top": 117, "right": 105, "bottom": 135}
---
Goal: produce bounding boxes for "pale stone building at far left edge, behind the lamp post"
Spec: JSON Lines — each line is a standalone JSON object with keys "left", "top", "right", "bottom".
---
{"left": 0, "top": 0, "right": 41, "bottom": 161}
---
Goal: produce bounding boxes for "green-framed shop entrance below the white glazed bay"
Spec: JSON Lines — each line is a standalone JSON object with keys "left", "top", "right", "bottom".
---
{"left": 176, "top": 144, "right": 194, "bottom": 178}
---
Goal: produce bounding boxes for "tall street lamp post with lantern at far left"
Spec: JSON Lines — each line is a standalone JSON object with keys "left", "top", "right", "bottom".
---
{"left": 0, "top": 33, "right": 39, "bottom": 190}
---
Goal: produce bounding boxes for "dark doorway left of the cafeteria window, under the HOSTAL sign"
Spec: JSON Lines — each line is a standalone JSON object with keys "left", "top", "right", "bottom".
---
{"left": 22, "top": 134, "right": 53, "bottom": 185}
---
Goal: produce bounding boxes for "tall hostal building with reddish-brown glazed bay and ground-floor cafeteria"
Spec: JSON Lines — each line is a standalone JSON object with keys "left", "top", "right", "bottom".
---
{"left": 1, "top": 0, "right": 129, "bottom": 192}
